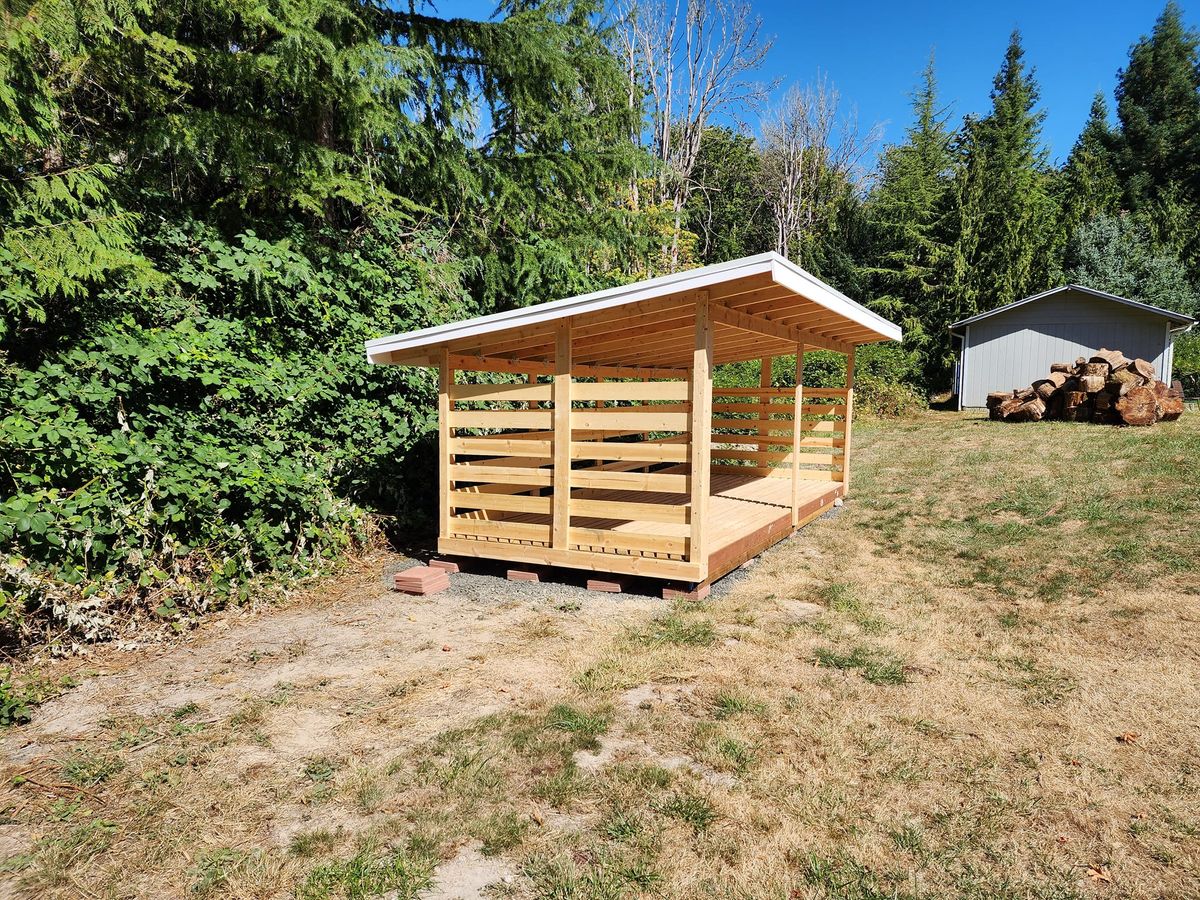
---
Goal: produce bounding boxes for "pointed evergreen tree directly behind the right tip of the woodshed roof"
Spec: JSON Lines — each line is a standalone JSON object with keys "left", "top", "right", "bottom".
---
{"left": 864, "top": 54, "right": 954, "bottom": 376}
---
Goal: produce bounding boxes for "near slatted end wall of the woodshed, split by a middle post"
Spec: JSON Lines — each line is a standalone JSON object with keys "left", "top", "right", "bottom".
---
{"left": 448, "top": 380, "right": 691, "bottom": 560}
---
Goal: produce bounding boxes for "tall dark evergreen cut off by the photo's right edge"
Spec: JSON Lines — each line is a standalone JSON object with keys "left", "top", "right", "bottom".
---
{"left": 1117, "top": 0, "right": 1200, "bottom": 271}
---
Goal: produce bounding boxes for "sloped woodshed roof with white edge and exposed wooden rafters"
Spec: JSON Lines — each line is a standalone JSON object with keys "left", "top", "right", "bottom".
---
{"left": 366, "top": 253, "right": 901, "bottom": 377}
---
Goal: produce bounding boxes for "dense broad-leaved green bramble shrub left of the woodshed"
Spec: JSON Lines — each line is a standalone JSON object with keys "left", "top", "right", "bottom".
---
{"left": 0, "top": 224, "right": 466, "bottom": 646}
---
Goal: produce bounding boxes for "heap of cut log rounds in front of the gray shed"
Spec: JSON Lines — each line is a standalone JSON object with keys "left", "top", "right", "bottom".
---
{"left": 988, "top": 348, "right": 1183, "bottom": 425}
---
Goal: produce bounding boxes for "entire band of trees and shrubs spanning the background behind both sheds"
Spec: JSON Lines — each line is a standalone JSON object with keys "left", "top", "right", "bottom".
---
{"left": 0, "top": 0, "right": 1200, "bottom": 646}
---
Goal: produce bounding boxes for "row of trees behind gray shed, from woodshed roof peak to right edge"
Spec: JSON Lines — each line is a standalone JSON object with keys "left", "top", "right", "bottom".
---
{"left": 672, "top": 4, "right": 1200, "bottom": 394}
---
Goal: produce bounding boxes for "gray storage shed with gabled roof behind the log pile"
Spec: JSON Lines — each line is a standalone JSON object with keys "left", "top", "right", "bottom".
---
{"left": 950, "top": 284, "right": 1195, "bottom": 409}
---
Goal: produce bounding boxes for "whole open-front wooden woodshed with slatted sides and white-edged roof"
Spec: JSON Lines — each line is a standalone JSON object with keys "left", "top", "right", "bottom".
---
{"left": 366, "top": 253, "right": 900, "bottom": 586}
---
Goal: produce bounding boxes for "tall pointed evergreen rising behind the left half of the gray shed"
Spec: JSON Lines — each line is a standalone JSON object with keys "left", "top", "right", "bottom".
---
{"left": 937, "top": 31, "right": 1054, "bottom": 374}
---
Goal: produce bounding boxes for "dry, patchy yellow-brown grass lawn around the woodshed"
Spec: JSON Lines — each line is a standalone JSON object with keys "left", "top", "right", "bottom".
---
{"left": 0, "top": 412, "right": 1200, "bottom": 900}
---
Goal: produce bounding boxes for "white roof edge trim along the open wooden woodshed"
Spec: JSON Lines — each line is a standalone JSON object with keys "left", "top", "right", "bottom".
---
{"left": 365, "top": 252, "right": 901, "bottom": 362}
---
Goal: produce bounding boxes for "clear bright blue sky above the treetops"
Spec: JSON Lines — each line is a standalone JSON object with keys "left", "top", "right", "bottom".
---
{"left": 424, "top": 0, "right": 1180, "bottom": 161}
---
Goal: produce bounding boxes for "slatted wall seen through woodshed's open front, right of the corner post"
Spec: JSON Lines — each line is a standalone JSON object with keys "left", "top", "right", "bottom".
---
{"left": 712, "top": 388, "right": 846, "bottom": 481}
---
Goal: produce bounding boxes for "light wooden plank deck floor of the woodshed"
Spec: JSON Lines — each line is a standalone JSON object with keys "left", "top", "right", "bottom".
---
{"left": 480, "top": 473, "right": 842, "bottom": 581}
